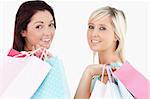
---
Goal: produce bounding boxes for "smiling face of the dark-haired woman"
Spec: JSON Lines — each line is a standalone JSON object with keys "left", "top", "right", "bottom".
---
{"left": 22, "top": 10, "right": 55, "bottom": 50}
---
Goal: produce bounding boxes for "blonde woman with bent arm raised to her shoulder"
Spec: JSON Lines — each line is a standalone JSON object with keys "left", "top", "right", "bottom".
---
{"left": 75, "top": 6, "right": 126, "bottom": 99}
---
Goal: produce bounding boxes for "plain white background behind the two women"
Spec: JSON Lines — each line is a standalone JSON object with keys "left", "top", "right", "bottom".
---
{"left": 0, "top": 0, "right": 150, "bottom": 97}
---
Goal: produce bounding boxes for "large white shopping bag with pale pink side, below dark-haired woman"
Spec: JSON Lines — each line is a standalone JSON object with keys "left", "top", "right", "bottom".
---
{"left": 0, "top": 56, "right": 51, "bottom": 99}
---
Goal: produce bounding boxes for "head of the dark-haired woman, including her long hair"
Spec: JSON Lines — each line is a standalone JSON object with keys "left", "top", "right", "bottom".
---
{"left": 13, "top": 1, "right": 56, "bottom": 51}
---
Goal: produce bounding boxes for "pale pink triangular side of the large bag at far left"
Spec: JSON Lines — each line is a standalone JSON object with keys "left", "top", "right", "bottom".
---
{"left": 0, "top": 56, "right": 26, "bottom": 95}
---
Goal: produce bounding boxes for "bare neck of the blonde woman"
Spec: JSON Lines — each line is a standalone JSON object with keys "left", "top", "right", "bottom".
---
{"left": 98, "top": 51, "right": 121, "bottom": 64}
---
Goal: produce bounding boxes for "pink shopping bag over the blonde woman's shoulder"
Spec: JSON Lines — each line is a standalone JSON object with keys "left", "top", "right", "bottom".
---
{"left": 114, "top": 61, "right": 150, "bottom": 99}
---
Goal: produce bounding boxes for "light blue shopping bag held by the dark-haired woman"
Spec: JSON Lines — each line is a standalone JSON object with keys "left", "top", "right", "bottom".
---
{"left": 31, "top": 57, "right": 70, "bottom": 99}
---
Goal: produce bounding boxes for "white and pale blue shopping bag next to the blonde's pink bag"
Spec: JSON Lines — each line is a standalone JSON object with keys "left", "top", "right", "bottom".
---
{"left": 105, "top": 66, "right": 134, "bottom": 99}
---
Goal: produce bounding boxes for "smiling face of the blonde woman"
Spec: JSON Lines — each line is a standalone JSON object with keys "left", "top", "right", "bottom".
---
{"left": 87, "top": 16, "right": 116, "bottom": 52}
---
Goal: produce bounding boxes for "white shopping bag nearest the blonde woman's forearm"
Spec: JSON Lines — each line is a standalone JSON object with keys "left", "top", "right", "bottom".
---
{"left": 90, "top": 65, "right": 106, "bottom": 99}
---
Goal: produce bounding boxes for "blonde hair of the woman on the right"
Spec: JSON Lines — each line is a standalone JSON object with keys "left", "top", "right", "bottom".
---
{"left": 89, "top": 6, "right": 126, "bottom": 62}
